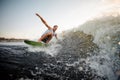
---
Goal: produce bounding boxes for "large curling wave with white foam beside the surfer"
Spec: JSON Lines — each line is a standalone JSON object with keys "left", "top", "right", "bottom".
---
{"left": 59, "top": 16, "right": 120, "bottom": 80}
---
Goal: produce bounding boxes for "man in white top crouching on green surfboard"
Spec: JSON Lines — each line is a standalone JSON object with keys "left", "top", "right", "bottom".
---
{"left": 36, "top": 13, "right": 58, "bottom": 43}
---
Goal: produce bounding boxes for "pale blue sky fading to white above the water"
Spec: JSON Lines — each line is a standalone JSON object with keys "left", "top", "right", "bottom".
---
{"left": 0, "top": 0, "right": 120, "bottom": 39}
